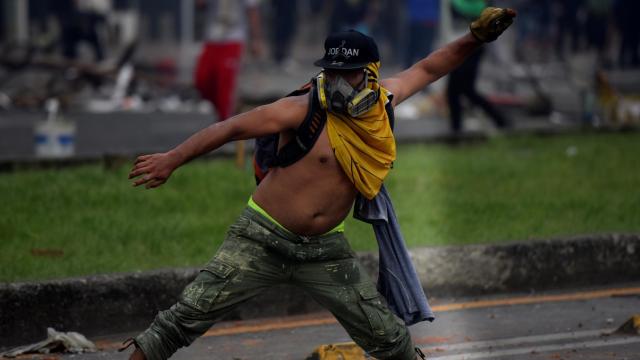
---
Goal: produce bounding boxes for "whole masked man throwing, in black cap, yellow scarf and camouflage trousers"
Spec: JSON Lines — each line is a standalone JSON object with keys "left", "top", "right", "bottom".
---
{"left": 123, "top": 8, "right": 516, "bottom": 360}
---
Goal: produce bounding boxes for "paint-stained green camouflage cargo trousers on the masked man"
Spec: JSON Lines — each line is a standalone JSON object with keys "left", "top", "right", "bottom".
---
{"left": 135, "top": 208, "right": 415, "bottom": 360}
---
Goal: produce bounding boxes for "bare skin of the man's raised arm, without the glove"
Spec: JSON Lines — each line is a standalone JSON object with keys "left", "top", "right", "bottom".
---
{"left": 381, "top": 33, "right": 482, "bottom": 106}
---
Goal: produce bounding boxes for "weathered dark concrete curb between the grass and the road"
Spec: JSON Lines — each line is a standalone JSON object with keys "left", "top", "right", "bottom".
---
{"left": 0, "top": 234, "right": 640, "bottom": 347}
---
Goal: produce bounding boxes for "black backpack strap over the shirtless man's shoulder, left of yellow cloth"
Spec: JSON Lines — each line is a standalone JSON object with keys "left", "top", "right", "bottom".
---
{"left": 274, "top": 79, "right": 327, "bottom": 167}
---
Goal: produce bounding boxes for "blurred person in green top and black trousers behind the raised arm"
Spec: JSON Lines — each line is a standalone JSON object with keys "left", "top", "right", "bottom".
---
{"left": 447, "top": 0, "right": 509, "bottom": 135}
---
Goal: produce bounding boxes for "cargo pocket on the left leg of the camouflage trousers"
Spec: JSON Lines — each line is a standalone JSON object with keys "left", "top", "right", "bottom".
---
{"left": 180, "top": 259, "right": 236, "bottom": 312}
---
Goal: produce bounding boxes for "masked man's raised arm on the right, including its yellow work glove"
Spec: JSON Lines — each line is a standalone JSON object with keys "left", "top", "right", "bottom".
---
{"left": 381, "top": 7, "right": 516, "bottom": 106}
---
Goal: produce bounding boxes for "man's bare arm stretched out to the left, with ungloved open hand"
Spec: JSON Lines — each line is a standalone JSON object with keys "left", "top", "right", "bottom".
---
{"left": 129, "top": 96, "right": 308, "bottom": 189}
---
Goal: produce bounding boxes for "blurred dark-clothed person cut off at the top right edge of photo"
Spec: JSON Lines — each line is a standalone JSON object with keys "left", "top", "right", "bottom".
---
{"left": 614, "top": 0, "right": 640, "bottom": 68}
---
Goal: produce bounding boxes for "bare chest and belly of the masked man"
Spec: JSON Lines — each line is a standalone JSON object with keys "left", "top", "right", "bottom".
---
{"left": 253, "top": 97, "right": 357, "bottom": 235}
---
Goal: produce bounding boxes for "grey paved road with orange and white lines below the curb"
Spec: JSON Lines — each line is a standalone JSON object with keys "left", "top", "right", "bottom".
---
{"left": 50, "top": 284, "right": 640, "bottom": 360}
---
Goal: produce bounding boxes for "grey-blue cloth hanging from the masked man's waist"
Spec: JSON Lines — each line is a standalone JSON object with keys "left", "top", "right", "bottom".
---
{"left": 353, "top": 185, "right": 435, "bottom": 325}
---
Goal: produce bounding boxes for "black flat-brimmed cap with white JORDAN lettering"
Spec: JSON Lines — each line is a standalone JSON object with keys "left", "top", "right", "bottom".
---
{"left": 313, "top": 30, "right": 380, "bottom": 70}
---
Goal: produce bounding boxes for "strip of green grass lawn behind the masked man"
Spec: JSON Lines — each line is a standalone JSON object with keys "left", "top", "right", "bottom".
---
{"left": 0, "top": 132, "right": 640, "bottom": 282}
